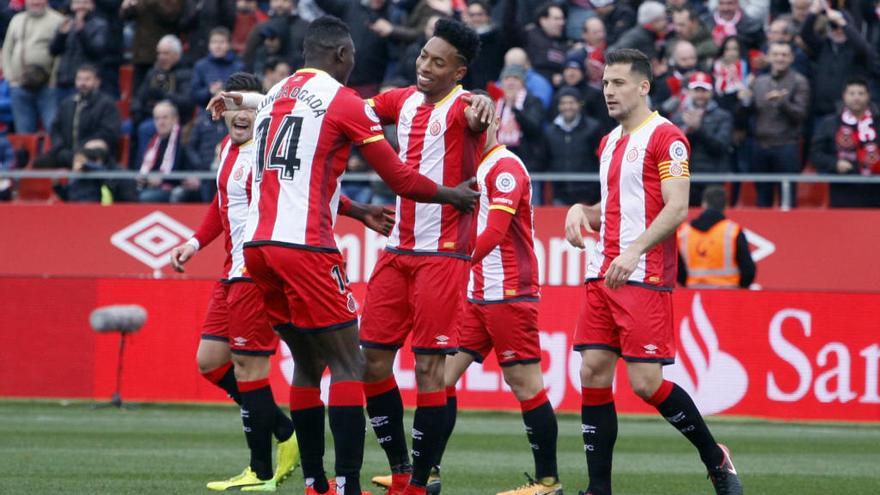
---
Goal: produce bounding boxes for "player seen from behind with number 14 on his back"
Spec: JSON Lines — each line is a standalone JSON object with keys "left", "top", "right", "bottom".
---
{"left": 209, "top": 16, "right": 479, "bottom": 495}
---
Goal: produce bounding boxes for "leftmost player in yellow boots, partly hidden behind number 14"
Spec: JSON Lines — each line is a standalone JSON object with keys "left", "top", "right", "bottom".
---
{"left": 171, "top": 72, "right": 299, "bottom": 491}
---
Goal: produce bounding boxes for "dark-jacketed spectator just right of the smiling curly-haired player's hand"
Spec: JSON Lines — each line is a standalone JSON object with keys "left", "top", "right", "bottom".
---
{"left": 495, "top": 65, "right": 544, "bottom": 174}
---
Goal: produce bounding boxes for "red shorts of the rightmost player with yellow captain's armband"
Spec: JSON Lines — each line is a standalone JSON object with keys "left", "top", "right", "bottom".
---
{"left": 574, "top": 281, "right": 675, "bottom": 364}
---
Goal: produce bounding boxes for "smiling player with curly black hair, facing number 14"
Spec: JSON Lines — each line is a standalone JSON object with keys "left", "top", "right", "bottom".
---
{"left": 361, "top": 19, "right": 494, "bottom": 495}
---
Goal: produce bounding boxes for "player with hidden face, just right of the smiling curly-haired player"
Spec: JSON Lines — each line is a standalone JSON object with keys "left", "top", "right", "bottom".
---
{"left": 437, "top": 108, "right": 562, "bottom": 495}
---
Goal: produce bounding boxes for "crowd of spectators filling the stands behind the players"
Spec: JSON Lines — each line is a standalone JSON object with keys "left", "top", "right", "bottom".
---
{"left": 0, "top": 0, "right": 880, "bottom": 207}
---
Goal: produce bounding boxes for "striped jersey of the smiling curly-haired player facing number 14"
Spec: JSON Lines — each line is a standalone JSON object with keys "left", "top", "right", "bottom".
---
{"left": 367, "top": 86, "right": 485, "bottom": 257}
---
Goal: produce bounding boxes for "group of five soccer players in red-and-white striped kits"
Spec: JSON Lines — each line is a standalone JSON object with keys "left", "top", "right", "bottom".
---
{"left": 171, "top": 16, "right": 742, "bottom": 495}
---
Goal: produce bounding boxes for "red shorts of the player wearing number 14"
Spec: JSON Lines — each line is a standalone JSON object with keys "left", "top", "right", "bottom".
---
{"left": 244, "top": 245, "right": 357, "bottom": 333}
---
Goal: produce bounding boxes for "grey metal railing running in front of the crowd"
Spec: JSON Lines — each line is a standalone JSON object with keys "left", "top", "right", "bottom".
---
{"left": 0, "top": 169, "right": 880, "bottom": 210}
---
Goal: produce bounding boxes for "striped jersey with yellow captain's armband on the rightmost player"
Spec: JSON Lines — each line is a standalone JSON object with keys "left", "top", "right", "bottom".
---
{"left": 587, "top": 112, "right": 690, "bottom": 288}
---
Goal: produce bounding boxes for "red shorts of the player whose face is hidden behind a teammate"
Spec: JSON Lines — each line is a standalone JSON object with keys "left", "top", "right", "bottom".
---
{"left": 458, "top": 301, "right": 541, "bottom": 366}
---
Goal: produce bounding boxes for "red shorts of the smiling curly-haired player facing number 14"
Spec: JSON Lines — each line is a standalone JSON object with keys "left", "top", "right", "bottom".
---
{"left": 361, "top": 251, "right": 470, "bottom": 354}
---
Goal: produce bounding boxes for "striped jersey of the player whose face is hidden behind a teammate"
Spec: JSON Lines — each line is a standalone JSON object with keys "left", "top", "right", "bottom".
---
{"left": 468, "top": 145, "right": 540, "bottom": 302}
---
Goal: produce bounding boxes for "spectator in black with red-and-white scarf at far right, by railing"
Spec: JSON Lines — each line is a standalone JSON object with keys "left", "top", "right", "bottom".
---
{"left": 810, "top": 77, "right": 880, "bottom": 208}
